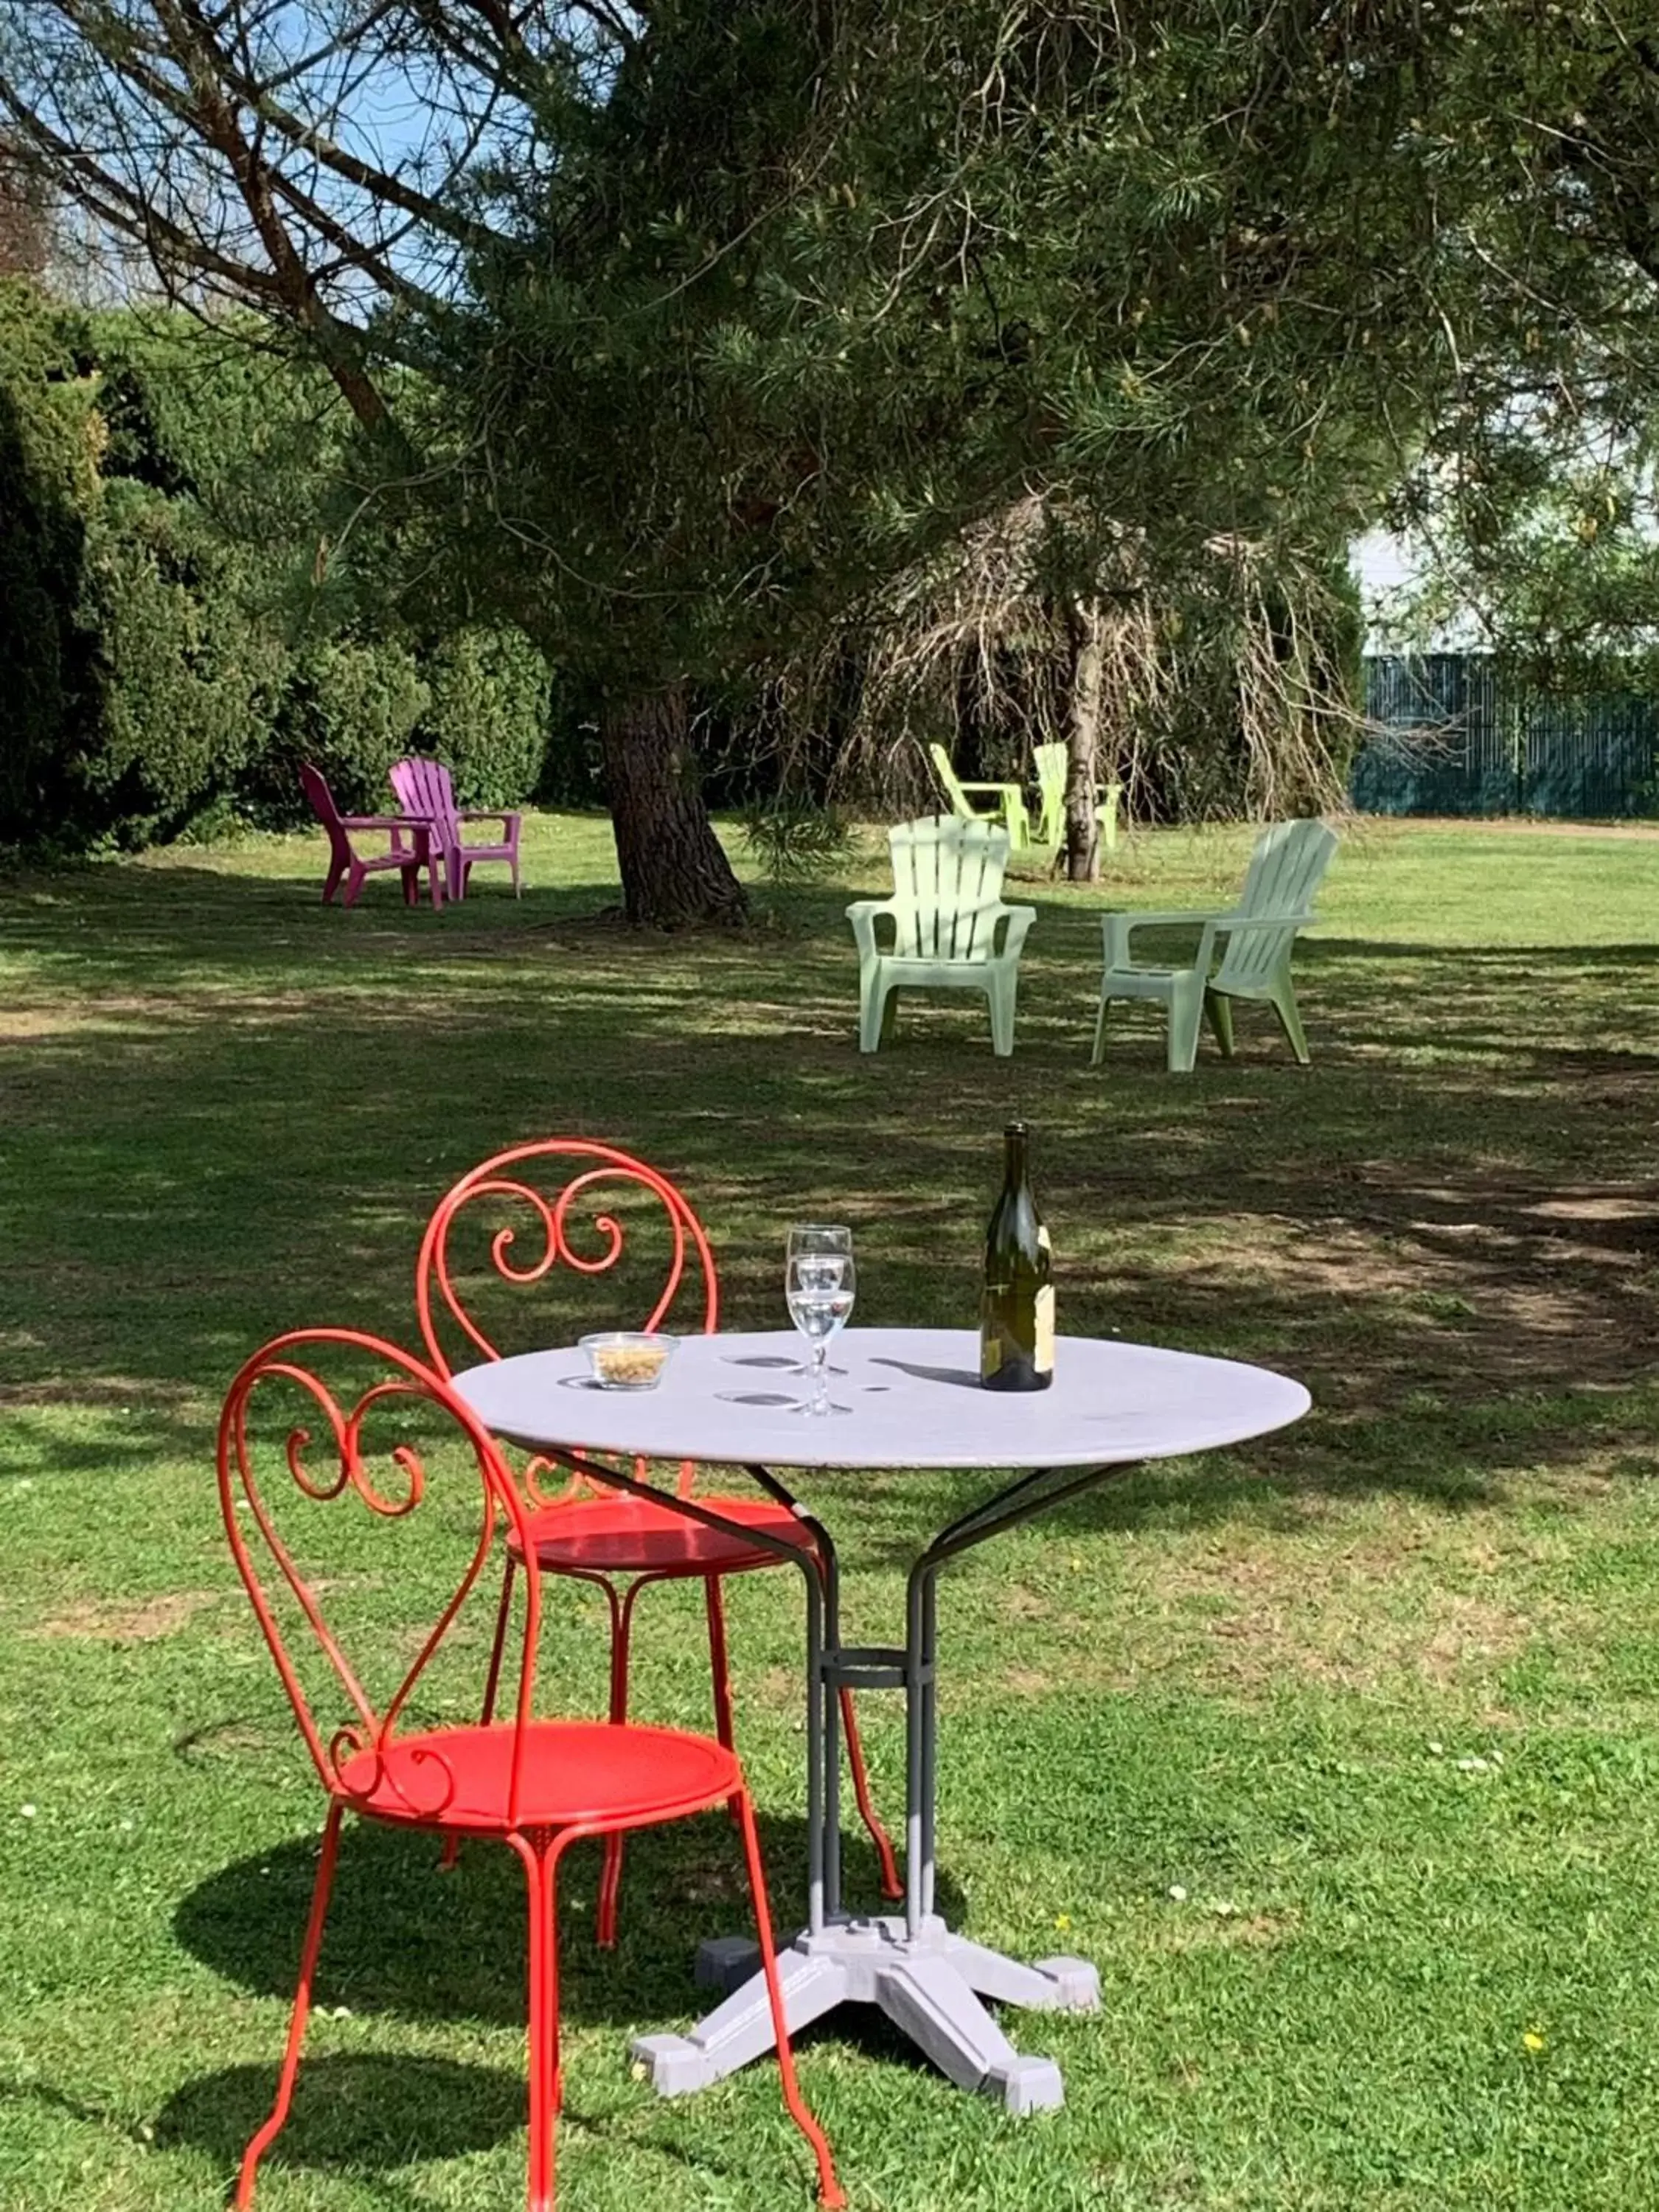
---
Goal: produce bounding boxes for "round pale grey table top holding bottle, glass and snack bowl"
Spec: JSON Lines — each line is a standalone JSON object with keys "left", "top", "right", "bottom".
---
{"left": 453, "top": 1329, "right": 1312, "bottom": 1469}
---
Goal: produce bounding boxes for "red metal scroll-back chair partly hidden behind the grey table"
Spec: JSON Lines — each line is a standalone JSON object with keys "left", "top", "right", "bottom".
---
{"left": 416, "top": 1137, "right": 905, "bottom": 1944}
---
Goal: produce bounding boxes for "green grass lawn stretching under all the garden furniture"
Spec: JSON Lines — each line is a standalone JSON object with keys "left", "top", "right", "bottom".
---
{"left": 0, "top": 816, "right": 1659, "bottom": 2212}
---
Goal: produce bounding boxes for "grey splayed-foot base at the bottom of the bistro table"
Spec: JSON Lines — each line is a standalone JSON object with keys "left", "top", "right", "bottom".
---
{"left": 633, "top": 1916, "right": 1099, "bottom": 2112}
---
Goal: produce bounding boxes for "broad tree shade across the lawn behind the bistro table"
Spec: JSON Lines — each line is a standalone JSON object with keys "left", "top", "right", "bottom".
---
{"left": 0, "top": 845, "right": 1659, "bottom": 1559}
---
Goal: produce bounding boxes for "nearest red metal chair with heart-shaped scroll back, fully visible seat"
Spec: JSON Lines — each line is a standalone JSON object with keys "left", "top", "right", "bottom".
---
{"left": 219, "top": 1329, "right": 847, "bottom": 2212}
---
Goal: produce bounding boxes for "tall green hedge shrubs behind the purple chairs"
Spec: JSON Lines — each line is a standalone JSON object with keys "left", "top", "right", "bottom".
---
{"left": 0, "top": 283, "right": 562, "bottom": 845}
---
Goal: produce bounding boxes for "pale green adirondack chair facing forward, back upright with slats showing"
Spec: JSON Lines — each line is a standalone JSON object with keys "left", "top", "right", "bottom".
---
{"left": 847, "top": 814, "right": 1037, "bottom": 1060}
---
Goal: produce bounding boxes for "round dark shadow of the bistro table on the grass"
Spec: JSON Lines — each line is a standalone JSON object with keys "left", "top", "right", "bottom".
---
{"left": 173, "top": 1814, "right": 964, "bottom": 2031}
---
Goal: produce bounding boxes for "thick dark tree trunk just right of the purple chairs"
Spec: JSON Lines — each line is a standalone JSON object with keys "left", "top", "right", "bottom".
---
{"left": 599, "top": 684, "right": 748, "bottom": 929}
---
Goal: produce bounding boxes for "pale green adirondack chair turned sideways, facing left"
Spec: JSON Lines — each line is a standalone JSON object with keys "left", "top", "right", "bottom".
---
{"left": 1091, "top": 821, "right": 1336, "bottom": 1075}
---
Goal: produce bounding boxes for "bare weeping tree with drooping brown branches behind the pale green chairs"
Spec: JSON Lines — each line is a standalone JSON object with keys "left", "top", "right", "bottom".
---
{"left": 805, "top": 493, "right": 1358, "bottom": 883}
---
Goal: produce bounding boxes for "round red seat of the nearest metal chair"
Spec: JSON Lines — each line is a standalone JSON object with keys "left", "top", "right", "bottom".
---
{"left": 341, "top": 1721, "right": 743, "bottom": 1836}
